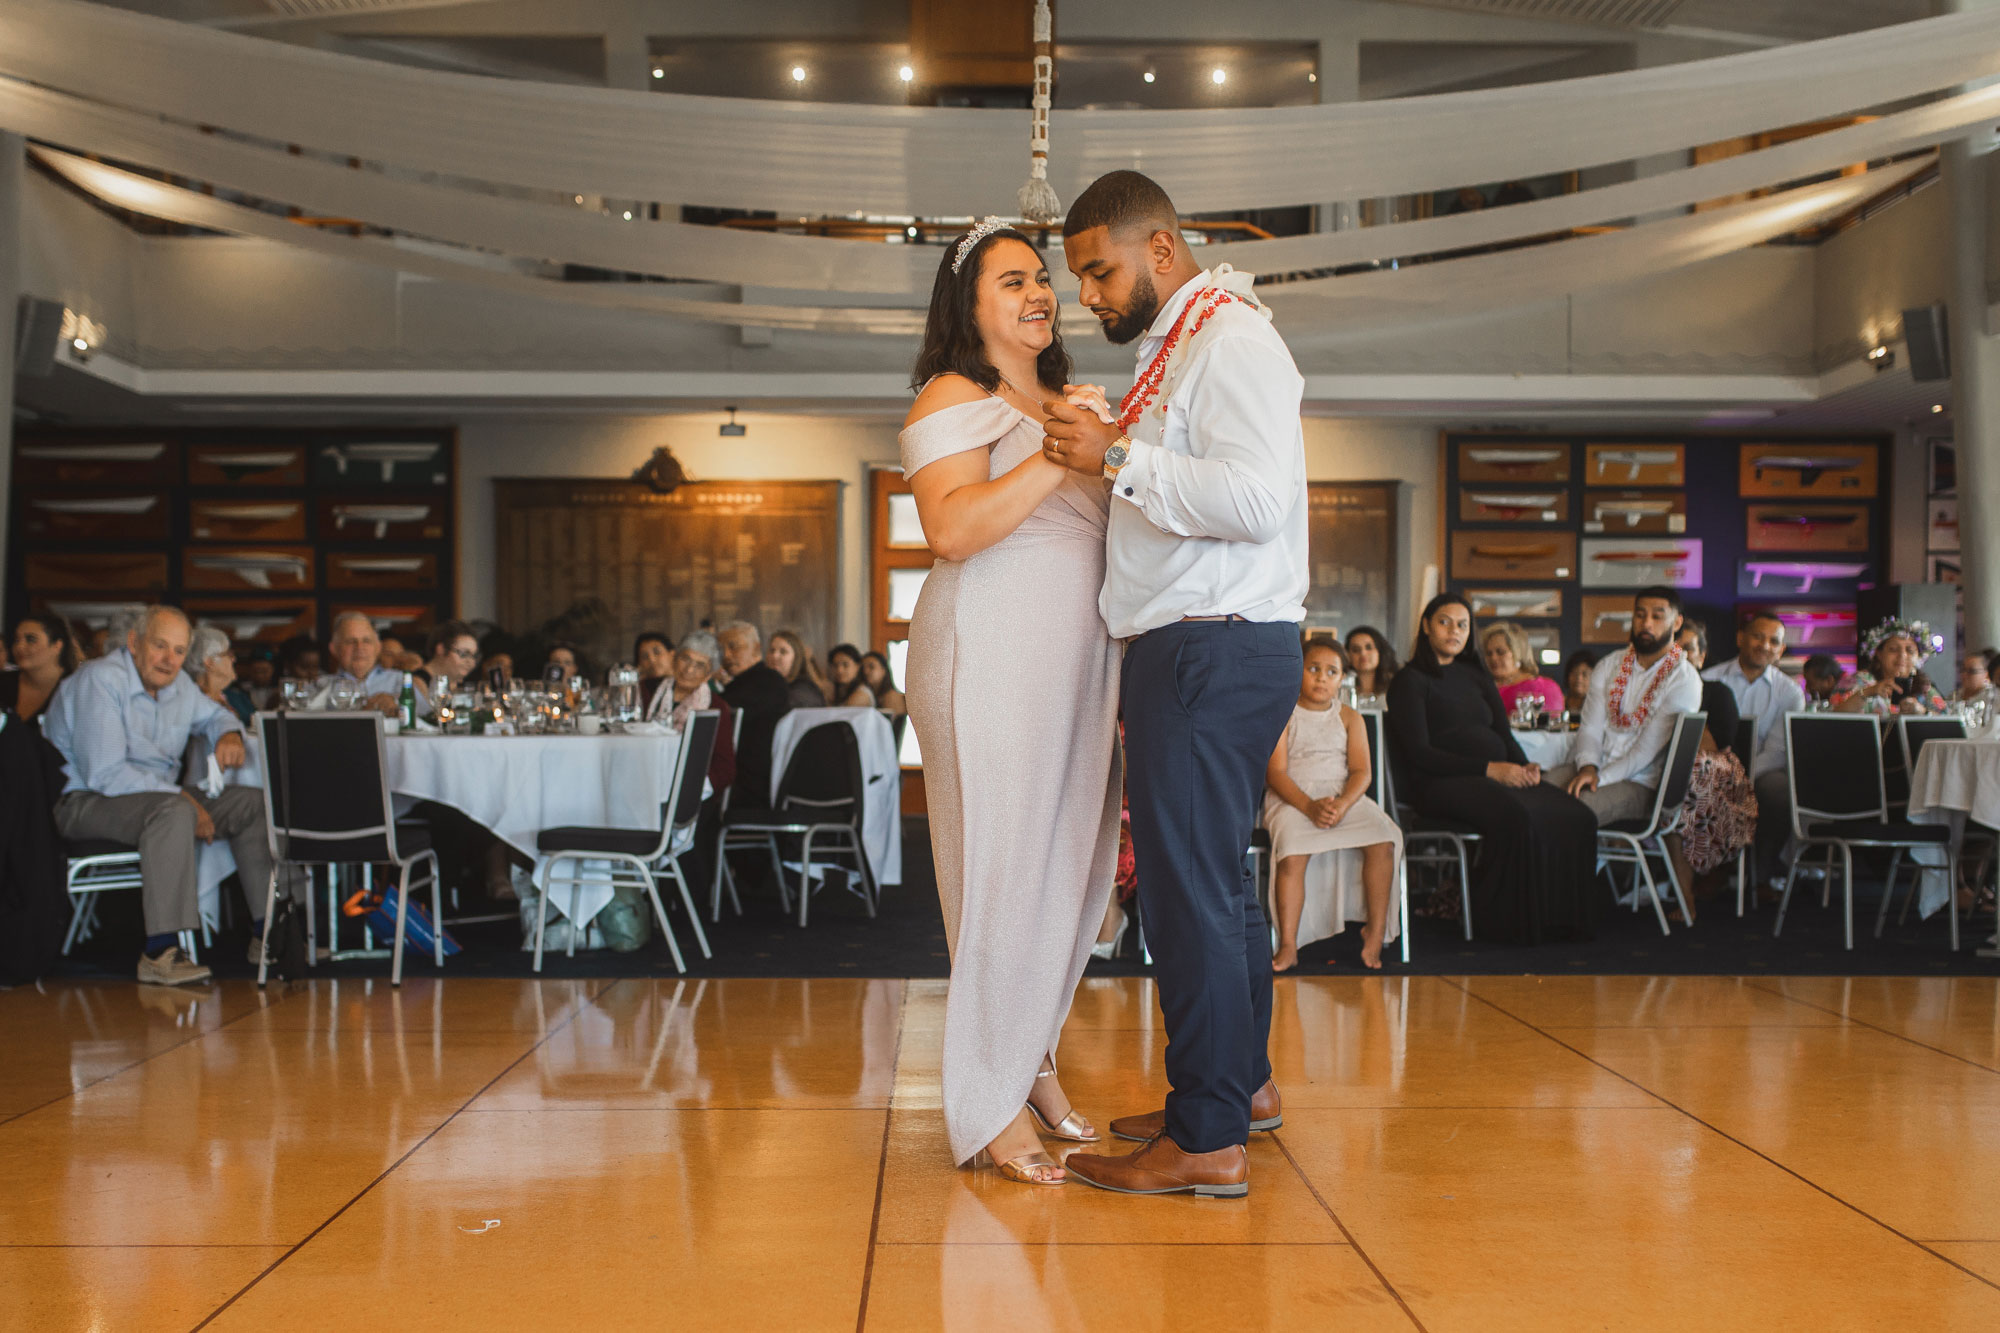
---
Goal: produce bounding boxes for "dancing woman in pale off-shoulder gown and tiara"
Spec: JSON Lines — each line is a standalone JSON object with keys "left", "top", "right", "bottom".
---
{"left": 902, "top": 218, "right": 1120, "bottom": 1185}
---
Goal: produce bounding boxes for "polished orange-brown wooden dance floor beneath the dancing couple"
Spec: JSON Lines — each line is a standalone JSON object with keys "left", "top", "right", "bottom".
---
{"left": 0, "top": 977, "right": 2000, "bottom": 1333}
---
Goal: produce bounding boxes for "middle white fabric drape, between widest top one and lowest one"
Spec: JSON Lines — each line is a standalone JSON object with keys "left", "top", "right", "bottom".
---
{"left": 0, "top": 78, "right": 2000, "bottom": 296}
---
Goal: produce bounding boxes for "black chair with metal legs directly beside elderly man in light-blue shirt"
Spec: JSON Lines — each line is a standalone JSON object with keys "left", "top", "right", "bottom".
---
{"left": 256, "top": 713, "right": 444, "bottom": 987}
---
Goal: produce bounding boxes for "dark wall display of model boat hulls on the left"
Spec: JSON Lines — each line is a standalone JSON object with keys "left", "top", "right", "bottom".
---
{"left": 6, "top": 428, "right": 456, "bottom": 642}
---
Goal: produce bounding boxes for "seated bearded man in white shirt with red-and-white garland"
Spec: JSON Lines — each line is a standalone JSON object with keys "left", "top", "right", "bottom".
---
{"left": 1550, "top": 588, "right": 1702, "bottom": 825}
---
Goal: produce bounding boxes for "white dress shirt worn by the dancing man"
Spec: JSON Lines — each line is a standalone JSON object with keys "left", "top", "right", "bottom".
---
{"left": 1098, "top": 272, "right": 1310, "bottom": 638}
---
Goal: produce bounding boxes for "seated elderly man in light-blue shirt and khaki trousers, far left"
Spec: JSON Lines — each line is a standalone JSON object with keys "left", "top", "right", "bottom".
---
{"left": 48, "top": 606, "right": 298, "bottom": 987}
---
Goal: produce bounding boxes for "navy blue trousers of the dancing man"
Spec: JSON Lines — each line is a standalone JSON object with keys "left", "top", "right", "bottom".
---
{"left": 1122, "top": 620, "right": 1302, "bottom": 1153}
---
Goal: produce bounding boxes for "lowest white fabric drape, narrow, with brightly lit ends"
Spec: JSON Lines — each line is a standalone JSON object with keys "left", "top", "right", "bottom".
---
{"left": 34, "top": 148, "right": 1928, "bottom": 334}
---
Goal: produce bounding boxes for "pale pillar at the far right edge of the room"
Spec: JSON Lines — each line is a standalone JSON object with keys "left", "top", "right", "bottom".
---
{"left": 1942, "top": 140, "right": 2000, "bottom": 648}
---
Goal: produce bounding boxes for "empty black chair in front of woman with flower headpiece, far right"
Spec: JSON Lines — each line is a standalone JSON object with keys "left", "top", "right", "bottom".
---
{"left": 1772, "top": 713, "right": 1958, "bottom": 953}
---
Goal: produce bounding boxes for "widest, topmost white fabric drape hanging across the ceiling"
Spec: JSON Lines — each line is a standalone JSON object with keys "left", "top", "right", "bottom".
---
{"left": 0, "top": 0, "right": 2000, "bottom": 213}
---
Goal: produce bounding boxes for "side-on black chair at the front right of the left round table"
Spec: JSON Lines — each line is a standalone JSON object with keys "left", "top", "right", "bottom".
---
{"left": 534, "top": 709, "right": 722, "bottom": 973}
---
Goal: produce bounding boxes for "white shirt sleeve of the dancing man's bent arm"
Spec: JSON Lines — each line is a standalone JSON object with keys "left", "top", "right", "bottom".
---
{"left": 1112, "top": 336, "right": 1304, "bottom": 542}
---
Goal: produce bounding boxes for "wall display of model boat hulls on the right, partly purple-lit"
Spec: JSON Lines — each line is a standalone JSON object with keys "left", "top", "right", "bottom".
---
{"left": 1440, "top": 430, "right": 1880, "bottom": 658}
